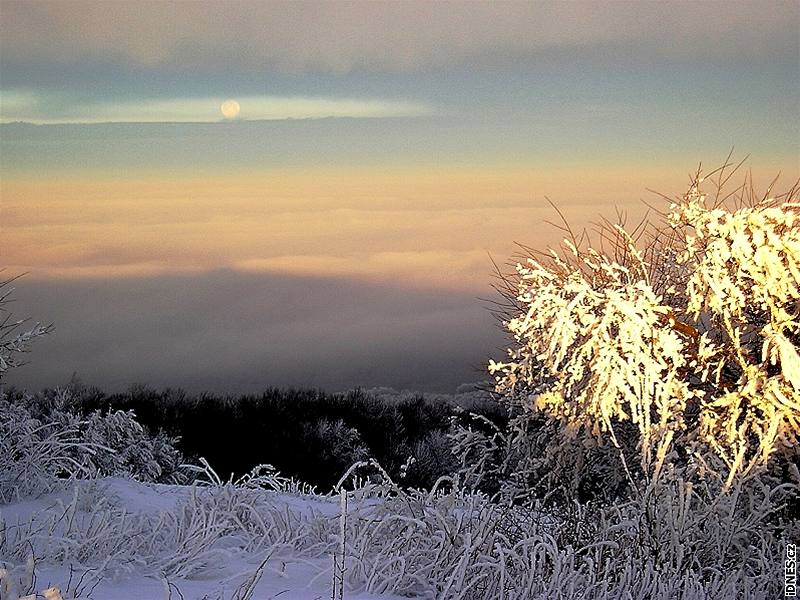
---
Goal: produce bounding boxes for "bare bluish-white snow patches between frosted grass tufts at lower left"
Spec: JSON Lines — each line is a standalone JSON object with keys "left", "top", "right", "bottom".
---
{"left": 0, "top": 477, "right": 407, "bottom": 600}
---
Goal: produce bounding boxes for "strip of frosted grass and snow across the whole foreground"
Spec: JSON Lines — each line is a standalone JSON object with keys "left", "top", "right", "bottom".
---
{"left": 0, "top": 450, "right": 783, "bottom": 600}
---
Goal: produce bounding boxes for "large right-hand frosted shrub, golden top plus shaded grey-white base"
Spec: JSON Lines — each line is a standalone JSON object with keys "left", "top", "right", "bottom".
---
{"left": 421, "top": 165, "right": 800, "bottom": 598}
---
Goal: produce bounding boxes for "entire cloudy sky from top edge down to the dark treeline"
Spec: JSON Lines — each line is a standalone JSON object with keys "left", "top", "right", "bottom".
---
{"left": 0, "top": 0, "right": 800, "bottom": 392}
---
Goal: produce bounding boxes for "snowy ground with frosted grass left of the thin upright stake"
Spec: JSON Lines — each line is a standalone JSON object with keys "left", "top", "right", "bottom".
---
{"left": 0, "top": 477, "right": 408, "bottom": 600}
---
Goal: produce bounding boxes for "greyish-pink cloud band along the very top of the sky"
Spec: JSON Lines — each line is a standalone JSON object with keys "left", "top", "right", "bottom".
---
{"left": 0, "top": 0, "right": 800, "bottom": 73}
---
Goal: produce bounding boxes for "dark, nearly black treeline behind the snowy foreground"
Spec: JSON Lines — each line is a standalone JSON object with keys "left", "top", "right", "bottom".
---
{"left": 7, "top": 383, "right": 507, "bottom": 491}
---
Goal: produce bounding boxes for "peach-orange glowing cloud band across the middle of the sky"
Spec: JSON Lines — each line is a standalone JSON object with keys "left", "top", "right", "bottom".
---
{"left": 9, "top": 167, "right": 788, "bottom": 291}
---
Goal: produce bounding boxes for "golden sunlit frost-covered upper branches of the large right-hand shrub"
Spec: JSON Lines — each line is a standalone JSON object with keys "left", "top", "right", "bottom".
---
{"left": 489, "top": 162, "right": 800, "bottom": 487}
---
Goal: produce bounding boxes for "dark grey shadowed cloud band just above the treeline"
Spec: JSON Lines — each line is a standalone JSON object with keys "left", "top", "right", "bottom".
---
{"left": 9, "top": 270, "right": 503, "bottom": 393}
